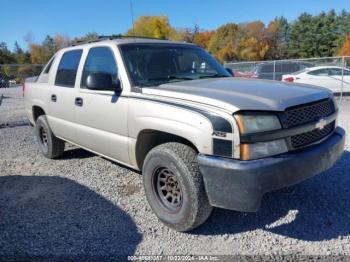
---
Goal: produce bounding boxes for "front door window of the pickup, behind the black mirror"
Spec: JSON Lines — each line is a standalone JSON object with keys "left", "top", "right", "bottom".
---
{"left": 80, "top": 47, "right": 118, "bottom": 88}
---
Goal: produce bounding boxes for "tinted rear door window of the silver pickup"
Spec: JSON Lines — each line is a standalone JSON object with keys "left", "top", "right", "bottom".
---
{"left": 55, "top": 49, "right": 83, "bottom": 87}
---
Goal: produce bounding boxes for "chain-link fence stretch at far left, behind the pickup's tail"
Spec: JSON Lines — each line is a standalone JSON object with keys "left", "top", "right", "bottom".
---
{"left": 0, "top": 64, "right": 44, "bottom": 88}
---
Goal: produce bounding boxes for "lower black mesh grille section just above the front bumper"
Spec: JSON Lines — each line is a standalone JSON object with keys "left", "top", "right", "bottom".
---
{"left": 291, "top": 121, "right": 335, "bottom": 148}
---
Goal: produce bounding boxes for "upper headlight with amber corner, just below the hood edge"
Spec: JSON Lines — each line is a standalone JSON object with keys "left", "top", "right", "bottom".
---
{"left": 235, "top": 113, "right": 281, "bottom": 134}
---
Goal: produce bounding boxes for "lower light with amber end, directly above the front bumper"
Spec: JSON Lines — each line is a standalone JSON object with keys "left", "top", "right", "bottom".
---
{"left": 241, "top": 139, "right": 288, "bottom": 160}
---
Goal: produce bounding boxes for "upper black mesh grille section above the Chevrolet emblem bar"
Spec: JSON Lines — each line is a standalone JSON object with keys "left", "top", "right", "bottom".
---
{"left": 280, "top": 99, "right": 335, "bottom": 128}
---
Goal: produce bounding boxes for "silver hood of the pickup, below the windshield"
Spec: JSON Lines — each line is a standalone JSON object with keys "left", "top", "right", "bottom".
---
{"left": 142, "top": 77, "right": 331, "bottom": 112}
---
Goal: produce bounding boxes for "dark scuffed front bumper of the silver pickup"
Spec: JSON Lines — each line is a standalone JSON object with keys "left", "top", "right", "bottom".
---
{"left": 198, "top": 127, "right": 345, "bottom": 212}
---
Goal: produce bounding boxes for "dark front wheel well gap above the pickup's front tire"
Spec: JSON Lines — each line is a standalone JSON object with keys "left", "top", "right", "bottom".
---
{"left": 135, "top": 130, "right": 198, "bottom": 170}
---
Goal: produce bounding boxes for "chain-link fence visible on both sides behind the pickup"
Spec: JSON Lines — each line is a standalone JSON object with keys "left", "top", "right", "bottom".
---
{"left": 0, "top": 56, "right": 350, "bottom": 97}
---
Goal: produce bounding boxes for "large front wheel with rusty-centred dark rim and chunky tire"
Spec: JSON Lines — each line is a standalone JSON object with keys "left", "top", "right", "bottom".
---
{"left": 142, "top": 142, "right": 212, "bottom": 231}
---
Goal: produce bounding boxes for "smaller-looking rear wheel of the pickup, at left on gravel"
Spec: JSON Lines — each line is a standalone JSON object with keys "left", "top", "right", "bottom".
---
{"left": 35, "top": 115, "right": 64, "bottom": 158}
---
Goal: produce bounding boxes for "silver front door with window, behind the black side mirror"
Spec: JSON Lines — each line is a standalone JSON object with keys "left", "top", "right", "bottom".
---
{"left": 76, "top": 46, "right": 129, "bottom": 163}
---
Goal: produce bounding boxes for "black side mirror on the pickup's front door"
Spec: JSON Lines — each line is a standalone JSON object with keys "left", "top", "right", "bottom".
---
{"left": 86, "top": 73, "right": 122, "bottom": 92}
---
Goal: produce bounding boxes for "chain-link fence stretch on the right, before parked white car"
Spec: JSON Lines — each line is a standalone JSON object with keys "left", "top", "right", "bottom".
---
{"left": 224, "top": 56, "right": 350, "bottom": 96}
